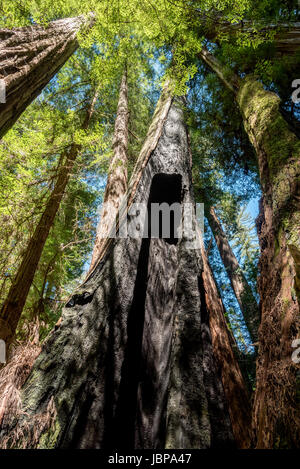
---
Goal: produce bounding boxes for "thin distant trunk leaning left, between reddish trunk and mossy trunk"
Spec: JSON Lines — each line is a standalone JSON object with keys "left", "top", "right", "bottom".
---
{"left": 207, "top": 207, "right": 259, "bottom": 343}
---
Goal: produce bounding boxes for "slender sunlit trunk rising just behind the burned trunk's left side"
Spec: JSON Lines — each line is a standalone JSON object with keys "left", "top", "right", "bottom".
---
{"left": 90, "top": 69, "right": 128, "bottom": 271}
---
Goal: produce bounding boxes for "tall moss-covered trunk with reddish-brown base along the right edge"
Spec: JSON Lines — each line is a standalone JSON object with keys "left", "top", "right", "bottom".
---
{"left": 200, "top": 48, "right": 300, "bottom": 448}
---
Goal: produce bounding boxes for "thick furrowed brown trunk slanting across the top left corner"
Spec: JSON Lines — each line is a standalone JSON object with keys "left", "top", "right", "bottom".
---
{"left": 0, "top": 15, "right": 93, "bottom": 138}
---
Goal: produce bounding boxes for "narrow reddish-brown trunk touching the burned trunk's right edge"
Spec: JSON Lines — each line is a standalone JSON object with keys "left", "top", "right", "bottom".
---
{"left": 201, "top": 232, "right": 251, "bottom": 449}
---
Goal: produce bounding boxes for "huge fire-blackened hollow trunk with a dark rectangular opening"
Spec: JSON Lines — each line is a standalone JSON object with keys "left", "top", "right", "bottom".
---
{"left": 1, "top": 88, "right": 233, "bottom": 449}
